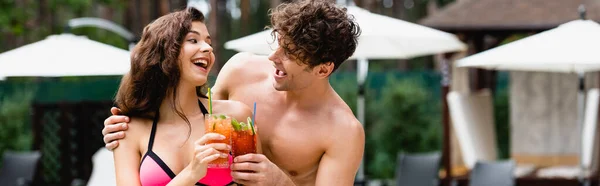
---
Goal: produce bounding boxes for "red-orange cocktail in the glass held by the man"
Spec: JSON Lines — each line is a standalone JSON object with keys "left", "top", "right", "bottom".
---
{"left": 231, "top": 118, "right": 257, "bottom": 157}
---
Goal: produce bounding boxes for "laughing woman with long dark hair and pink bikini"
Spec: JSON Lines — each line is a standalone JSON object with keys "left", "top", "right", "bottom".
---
{"left": 114, "top": 8, "right": 251, "bottom": 186}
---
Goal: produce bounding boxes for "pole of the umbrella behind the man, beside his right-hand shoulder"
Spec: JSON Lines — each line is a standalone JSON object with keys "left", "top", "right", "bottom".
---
{"left": 356, "top": 58, "right": 369, "bottom": 185}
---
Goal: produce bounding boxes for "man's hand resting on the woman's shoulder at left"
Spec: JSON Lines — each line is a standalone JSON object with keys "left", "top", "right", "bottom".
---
{"left": 102, "top": 107, "right": 129, "bottom": 151}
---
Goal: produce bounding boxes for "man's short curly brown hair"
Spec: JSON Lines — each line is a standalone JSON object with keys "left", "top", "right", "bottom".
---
{"left": 270, "top": 0, "right": 360, "bottom": 71}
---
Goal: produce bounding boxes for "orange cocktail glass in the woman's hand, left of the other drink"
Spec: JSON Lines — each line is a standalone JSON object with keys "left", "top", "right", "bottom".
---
{"left": 204, "top": 114, "right": 233, "bottom": 168}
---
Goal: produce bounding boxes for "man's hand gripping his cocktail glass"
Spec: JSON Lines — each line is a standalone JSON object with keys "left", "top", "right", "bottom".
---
{"left": 231, "top": 154, "right": 294, "bottom": 185}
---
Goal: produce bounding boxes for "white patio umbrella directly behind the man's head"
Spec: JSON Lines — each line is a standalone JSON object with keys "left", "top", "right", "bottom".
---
{"left": 225, "top": 6, "right": 467, "bottom": 180}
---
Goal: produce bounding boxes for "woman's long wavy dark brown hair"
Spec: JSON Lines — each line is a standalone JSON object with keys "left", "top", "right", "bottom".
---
{"left": 115, "top": 8, "right": 206, "bottom": 125}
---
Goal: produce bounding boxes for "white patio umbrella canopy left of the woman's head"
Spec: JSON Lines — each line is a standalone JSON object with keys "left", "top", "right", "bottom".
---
{"left": 0, "top": 34, "right": 130, "bottom": 79}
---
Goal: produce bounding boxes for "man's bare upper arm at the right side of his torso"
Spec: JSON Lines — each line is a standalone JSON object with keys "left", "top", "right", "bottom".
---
{"left": 315, "top": 119, "right": 365, "bottom": 186}
